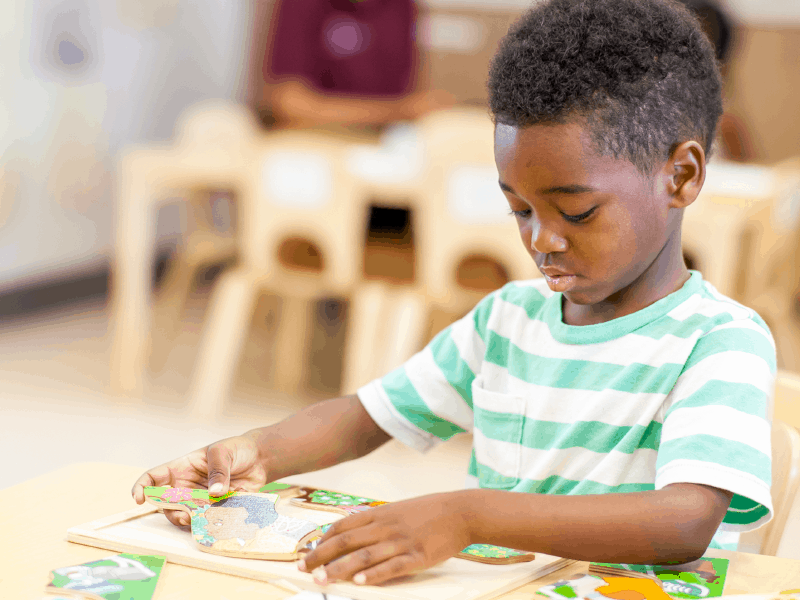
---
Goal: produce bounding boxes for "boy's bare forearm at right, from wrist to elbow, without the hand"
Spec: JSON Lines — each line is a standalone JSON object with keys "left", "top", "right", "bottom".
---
{"left": 465, "top": 483, "right": 732, "bottom": 564}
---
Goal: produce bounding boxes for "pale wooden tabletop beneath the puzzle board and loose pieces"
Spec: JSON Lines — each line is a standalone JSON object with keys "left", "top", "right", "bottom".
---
{"left": 0, "top": 457, "right": 800, "bottom": 600}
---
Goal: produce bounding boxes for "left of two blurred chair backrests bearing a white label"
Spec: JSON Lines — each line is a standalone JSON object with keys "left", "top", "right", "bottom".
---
{"left": 240, "top": 130, "right": 369, "bottom": 293}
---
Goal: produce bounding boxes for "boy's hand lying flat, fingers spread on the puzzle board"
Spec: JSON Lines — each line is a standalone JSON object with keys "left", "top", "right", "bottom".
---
{"left": 298, "top": 492, "right": 470, "bottom": 585}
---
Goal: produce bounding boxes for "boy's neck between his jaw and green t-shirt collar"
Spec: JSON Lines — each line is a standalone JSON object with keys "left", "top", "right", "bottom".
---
{"left": 562, "top": 227, "right": 691, "bottom": 326}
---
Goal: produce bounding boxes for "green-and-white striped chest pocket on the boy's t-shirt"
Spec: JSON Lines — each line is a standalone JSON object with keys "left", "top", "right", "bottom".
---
{"left": 472, "top": 376, "right": 526, "bottom": 490}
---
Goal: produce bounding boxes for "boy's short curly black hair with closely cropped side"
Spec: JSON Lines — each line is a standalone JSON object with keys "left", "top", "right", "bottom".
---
{"left": 488, "top": 0, "right": 722, "bottom": 173}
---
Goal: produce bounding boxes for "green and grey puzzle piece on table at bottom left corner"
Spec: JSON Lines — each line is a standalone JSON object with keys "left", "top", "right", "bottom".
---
{"left": 45, "top": 554, "right": 166, "bottom": 600}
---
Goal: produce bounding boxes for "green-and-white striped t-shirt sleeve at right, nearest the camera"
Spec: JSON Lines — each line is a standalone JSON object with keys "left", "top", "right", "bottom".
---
{"left": 655, "top": 315, "right": 776, "bottom": 532}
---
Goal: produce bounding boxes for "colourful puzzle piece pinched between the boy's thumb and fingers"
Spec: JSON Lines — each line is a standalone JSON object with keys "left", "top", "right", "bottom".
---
{"left": 144, "top": 487, "right": 320, "bottom": 560}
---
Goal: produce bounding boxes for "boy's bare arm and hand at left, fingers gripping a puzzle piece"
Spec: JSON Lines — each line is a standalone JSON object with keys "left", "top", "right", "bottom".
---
{"left": 131, "top": 395, "right": 390, "bottom": 525}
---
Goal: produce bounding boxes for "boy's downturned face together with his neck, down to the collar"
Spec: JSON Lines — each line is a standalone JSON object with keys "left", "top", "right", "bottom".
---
{"left": 495, "top": 123, "right": 685, "bottom": 324}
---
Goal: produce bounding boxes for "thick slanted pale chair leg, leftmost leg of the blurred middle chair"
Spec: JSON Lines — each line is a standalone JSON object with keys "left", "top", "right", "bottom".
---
{"left": 189, "top": 269, "right": 259, "bottom": 419}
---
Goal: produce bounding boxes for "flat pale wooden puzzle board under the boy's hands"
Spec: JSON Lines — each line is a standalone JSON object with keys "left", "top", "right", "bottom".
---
{"left": 67, "top": 505, "right": 573, "bottom": 600}
